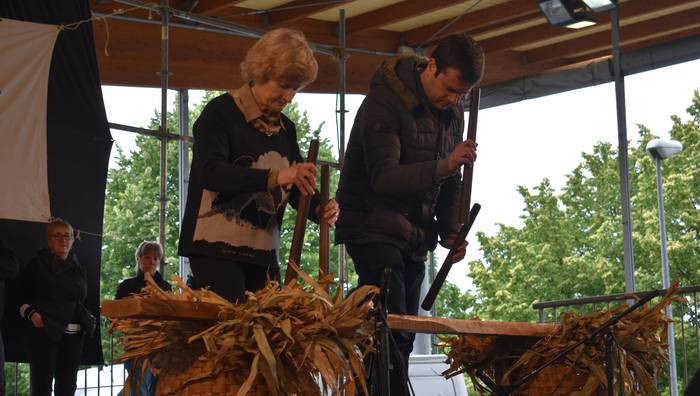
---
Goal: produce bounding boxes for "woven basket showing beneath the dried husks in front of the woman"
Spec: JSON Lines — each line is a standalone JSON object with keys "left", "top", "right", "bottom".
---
{"left": 156, "top": 360, "right": 267, "bottom": 396}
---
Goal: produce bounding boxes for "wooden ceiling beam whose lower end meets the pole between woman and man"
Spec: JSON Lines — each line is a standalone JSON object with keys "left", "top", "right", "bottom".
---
{"left": 345, "top": 0, "right": 464, "bottom": 35}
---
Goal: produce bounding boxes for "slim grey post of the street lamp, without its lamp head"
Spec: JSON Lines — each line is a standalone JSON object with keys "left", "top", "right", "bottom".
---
{"left": 654, "top": 157, "right": 678, "bottom": 396}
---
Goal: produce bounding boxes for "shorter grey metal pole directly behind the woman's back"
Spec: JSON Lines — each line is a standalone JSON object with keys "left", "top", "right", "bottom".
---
{"left": 177, "top": 89, "right": 190, "bottom": 279}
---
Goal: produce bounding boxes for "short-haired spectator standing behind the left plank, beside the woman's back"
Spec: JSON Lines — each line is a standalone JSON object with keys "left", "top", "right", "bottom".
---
{"left": 115, "top": 241, "right": 171, "bottom": 396}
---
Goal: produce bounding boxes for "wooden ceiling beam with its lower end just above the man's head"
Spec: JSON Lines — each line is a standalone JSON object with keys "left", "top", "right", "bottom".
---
{"left": 403, "top": 0, "right": 540, "bottom": 46}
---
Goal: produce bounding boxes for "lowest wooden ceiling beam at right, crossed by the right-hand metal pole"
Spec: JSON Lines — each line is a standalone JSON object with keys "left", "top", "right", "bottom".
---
{"left": 524, "top": 8, "right": 700, "bottom": 63}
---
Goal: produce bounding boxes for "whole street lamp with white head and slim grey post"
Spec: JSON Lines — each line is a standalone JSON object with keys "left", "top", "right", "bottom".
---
{"left": 647, "top": 139, "right": 683, "bottom": 396}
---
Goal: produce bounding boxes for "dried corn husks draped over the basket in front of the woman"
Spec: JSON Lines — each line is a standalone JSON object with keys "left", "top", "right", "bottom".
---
{"left": 110, "top": 264, "right": 378, "bottom": 396}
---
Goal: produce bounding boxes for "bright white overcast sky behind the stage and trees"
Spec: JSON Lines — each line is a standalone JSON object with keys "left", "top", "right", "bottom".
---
{"left": 103, "top": 61, "right": 700, "bottom": 288}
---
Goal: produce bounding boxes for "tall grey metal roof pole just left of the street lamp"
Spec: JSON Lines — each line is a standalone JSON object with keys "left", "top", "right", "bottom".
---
{"left": 610, "top": 7, "right": 636, "bottom": 293}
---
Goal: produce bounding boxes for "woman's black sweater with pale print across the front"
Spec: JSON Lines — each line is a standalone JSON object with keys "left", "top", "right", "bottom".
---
{"left": 178, "top": 94, "right": 319, "bottom": 267}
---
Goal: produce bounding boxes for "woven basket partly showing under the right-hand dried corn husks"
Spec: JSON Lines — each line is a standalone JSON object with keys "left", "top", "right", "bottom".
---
{"left": 515, "top": 364, "right": 600, "bottom": 396}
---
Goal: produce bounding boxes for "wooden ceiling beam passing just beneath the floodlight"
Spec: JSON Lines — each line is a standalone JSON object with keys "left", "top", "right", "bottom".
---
{"left": 481, "top": 0, "right": 687, "bottom": 52}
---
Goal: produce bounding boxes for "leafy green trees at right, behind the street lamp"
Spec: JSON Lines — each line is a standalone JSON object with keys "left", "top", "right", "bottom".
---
{"left": 464, "top": 91, "right": 700, "bottom": 321}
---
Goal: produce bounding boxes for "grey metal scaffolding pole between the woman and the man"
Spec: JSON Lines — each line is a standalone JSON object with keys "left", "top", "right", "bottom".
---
{"left": 336, "top": 8, "right": 347, "bottom": 294}
